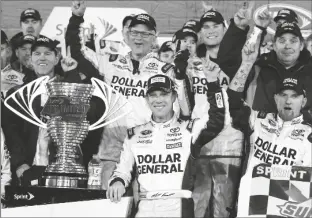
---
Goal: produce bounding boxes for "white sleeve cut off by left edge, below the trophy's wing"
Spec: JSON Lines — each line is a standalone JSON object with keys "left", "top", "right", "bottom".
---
{"left": 1, "top": 128, "right": 11, "bottom": 195}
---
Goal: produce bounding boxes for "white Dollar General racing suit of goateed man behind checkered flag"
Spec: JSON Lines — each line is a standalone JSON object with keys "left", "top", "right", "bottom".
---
{"left": 228, "top": 90, "right": 312, "bottom": 217}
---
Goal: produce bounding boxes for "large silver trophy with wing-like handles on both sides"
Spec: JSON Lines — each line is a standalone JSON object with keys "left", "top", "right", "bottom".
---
{"left": 4, "top": 76, "right": 131, "bottom": 188}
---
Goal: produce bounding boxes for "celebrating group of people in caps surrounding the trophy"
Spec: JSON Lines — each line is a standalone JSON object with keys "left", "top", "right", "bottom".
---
{"left": 1, "top": 1, "right": 312, "bottom": 217}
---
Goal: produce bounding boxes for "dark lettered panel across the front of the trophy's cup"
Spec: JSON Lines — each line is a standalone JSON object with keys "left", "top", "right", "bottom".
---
{"left": 41, "top": 96, "right": 90, "bottom": 122}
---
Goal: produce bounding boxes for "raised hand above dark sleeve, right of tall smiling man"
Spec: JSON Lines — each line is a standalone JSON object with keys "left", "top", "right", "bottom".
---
{"left": 234, "top": 1, "right": 255, "bottom": 30}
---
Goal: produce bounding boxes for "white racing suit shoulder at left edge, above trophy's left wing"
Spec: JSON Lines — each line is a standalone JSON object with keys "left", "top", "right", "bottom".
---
{"left": 1, "top": 64, "right": 25, "bottom": 99}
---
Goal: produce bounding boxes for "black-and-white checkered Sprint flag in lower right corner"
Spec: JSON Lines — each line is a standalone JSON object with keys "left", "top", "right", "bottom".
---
{"left": 241, "top": 164, "right": 312, "bottom": 217}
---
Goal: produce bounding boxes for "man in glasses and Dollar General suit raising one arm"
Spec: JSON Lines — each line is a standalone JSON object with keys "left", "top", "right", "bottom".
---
{"left": 66, "top": 1, "right": 189, "bottom": 189}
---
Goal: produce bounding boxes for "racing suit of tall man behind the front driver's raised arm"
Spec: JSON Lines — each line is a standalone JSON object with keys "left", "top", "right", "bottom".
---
{"left": 187, "top": 57, "right": 244, "bottom": 217}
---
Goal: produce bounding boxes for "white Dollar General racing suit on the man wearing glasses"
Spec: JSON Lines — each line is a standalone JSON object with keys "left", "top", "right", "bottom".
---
{"left": 66, "top": 15, "right": 190, "bottom": 189}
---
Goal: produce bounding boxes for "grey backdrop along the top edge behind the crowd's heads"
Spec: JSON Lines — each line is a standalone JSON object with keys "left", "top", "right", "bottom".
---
{"left": 1, "top": 0, "right": 312, "bottom": 37}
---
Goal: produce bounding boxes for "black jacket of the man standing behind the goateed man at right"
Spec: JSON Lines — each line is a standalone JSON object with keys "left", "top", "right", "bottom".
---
{"left": 246, "top": 50, "right": 312, "bottom": 113}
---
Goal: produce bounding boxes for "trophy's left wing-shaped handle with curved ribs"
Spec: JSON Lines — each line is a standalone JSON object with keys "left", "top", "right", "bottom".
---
{"left": 4, "top": 76, "right": 49, "bottom": 128}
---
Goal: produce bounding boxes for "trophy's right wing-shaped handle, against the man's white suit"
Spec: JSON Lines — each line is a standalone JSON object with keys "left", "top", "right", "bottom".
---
{"left": 89, "top": 78, "right": 131, "bottom": 131}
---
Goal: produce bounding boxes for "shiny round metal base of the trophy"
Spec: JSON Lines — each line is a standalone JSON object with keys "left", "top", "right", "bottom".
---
{"left": 41, "top": 173, "right": 88, "bottom": 188}
